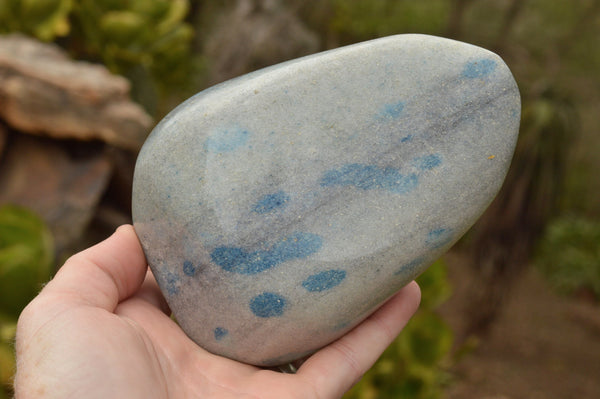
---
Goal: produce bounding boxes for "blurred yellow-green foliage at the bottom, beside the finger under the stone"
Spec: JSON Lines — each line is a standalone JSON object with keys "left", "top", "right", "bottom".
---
{"left": 344, "top": 259, "right": 454, "bottom": 399}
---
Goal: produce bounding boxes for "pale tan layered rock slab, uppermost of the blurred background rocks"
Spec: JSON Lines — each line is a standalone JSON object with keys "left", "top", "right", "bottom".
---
{"left": 0, "top": 35, "right": 152, "bottom": 150}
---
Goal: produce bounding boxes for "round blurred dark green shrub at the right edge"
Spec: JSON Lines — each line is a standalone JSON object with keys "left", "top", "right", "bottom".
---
{"left": 536, "top": 216, "right": 600, "bottom": 300}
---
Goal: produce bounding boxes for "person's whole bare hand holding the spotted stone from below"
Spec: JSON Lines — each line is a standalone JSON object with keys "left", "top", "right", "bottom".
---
{"left": 15, "top": 225, "right": 420, "bottom": 399}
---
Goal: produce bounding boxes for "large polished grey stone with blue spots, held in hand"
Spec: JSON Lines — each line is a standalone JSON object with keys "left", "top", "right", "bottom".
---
{"left": 133, "top": 35, "right": 520, "bottom": 366}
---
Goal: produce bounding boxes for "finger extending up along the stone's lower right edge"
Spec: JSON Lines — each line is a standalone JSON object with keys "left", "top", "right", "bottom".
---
{"left": 297, "top": 281, "right": 421, "bottom": 398}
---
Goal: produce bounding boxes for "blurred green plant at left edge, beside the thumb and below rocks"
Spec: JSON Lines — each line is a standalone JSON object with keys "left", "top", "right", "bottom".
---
{"left": 0, "top": 205, "right": 54, "bottom": 398}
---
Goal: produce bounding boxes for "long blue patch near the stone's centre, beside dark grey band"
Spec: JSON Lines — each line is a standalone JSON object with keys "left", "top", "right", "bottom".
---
{"left": 321, "top": 163, "right": 418, "bottom": 194}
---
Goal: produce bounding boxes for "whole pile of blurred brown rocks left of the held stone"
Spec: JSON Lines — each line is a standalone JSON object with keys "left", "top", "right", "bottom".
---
{"left": 0, "top": 35, "right": 153, "bottom": 258}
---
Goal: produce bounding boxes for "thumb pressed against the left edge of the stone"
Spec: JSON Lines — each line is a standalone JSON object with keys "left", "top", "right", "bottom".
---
{"left": 42, "top": 225, "right": 147, "bottom": 312}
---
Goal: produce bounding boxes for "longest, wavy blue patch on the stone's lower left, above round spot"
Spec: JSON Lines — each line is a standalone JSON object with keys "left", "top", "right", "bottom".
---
{"left": 211, "top": 232, "right": 323, "bottom": 274}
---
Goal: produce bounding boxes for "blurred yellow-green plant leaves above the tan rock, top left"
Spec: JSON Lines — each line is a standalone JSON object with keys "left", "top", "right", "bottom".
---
{"left": 0, "top": 0, "right": 197, "bottom": 113}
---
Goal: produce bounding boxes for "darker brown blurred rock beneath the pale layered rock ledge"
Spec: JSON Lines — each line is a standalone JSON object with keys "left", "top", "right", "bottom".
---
{"left": 0, "top": 135, "right": 112, "bottom": 256}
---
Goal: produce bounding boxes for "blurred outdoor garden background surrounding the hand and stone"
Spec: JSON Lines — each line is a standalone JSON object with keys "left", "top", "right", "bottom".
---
{"left": 0, "top": 0, "right": 600, "bottom": 399}
